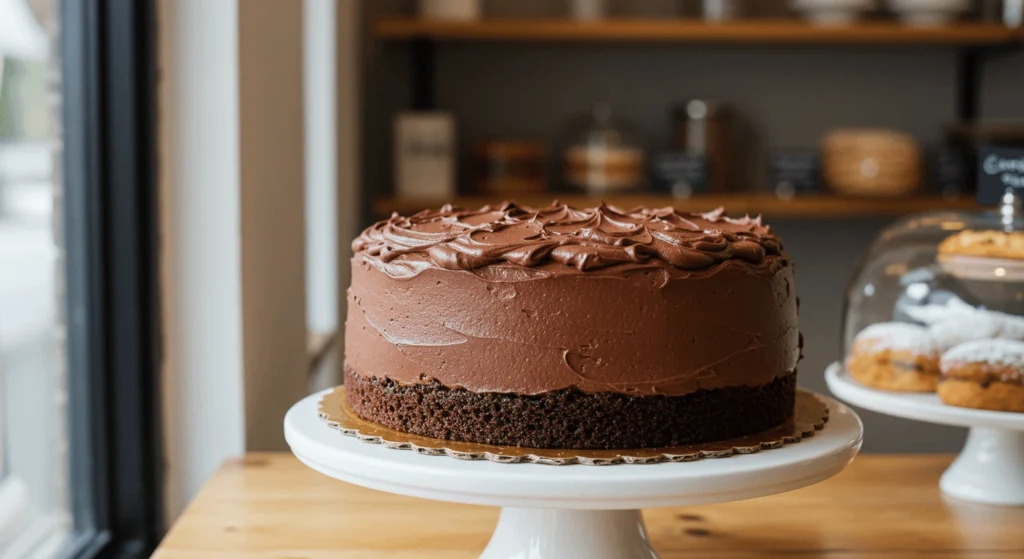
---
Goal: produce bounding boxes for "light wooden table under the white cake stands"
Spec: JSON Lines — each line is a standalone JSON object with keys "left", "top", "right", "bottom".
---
{"left": 154, "top": 454, "right": 1024, "bottom": 559}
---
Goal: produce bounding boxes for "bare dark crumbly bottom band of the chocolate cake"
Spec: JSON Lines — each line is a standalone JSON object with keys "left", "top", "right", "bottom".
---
{"left": 345, "top": 369, "right": 797, "bottom": 449}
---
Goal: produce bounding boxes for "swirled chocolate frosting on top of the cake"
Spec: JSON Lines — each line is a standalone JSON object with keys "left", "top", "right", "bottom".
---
{"left": 352, "top": 202, "right": 782, "bottom": 276}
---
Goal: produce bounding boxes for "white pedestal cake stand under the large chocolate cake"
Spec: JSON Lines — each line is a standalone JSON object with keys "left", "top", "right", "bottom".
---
{"left": 285, "top": 387, "right": 863, "bottom": 559}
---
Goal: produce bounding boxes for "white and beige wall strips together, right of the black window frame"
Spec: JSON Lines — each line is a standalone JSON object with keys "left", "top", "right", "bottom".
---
{"left": 159, "top": 0, "right": 308, "bottom": 519}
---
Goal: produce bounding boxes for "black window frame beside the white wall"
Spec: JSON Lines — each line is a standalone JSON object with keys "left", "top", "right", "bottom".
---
{"left": 56, "top": 0, "right": 164, "bottom": 559}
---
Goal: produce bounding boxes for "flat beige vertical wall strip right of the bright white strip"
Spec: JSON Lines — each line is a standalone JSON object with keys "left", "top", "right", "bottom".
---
{"left": 236, "top": 0, "right": 309, "bottom": 450}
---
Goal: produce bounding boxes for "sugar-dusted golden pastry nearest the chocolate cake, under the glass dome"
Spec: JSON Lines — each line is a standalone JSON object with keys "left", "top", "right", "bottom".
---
{"left": 846, "top": 323, "right": 940, "bottom": 392}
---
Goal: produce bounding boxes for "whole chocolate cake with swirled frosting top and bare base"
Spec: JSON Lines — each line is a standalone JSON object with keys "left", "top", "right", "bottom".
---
{"left": 345, "top": 203, "right": 801, "bottom": 448}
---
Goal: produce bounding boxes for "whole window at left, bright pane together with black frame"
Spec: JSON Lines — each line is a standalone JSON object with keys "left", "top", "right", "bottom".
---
{"left": 0, "top": 0, "right": 162, "bottom": 558}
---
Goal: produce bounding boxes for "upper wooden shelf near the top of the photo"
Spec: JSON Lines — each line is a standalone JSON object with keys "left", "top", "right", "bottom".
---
{"left": 374, "top": 18, "right": 1021, "bottom": 45}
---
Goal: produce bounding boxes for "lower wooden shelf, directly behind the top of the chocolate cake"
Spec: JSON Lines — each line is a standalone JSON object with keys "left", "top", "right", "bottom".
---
{"left": 374, "top": 192, "right": 977, "bottom": 219}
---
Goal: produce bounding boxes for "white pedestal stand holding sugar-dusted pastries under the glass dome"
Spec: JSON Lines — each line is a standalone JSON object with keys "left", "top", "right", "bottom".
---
{"left": 825, "top": 363, "right": 1024, "bottom": 506}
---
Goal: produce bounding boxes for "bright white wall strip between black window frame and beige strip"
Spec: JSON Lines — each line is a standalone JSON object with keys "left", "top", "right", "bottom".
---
{"left": 159, "top": 0, "right": 245, "bottom": 518}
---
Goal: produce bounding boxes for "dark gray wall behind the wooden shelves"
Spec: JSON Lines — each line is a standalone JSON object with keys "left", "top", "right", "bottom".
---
{"left": 362, "top": 0, "right": 1024, "bottom": 452}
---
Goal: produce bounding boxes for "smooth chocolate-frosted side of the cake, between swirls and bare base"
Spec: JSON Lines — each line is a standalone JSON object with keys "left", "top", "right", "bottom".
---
{"left": 345, "top": 256, "right": 800, "bottom": 395}
